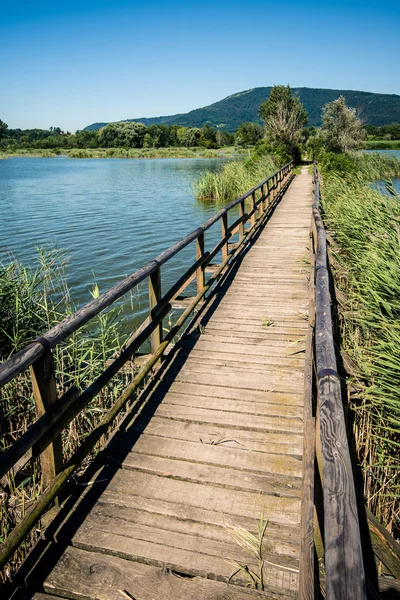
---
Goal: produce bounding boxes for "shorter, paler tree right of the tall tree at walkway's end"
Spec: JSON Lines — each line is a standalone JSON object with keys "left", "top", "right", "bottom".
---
{"left": 319, "top": 96, "right": 366, "bottom": 153}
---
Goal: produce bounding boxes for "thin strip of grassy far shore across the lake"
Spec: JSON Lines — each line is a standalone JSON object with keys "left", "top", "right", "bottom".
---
{"left": 0, "top": 146, "right": 245, "bottom": 159}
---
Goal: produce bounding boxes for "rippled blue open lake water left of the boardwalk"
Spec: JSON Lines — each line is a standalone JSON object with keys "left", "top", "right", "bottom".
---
{"left": 0, "top": 157, "right": 228, "bottom": 318}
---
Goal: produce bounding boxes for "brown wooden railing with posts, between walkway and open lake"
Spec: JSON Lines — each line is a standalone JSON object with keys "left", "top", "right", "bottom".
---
{"left": 0, "top": 162, "right": 293, "bottom": 568}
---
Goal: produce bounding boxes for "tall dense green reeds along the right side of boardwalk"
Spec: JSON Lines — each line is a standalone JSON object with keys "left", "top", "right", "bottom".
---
{"left": 322, "top": 154, "right": 400, "bottom": 537}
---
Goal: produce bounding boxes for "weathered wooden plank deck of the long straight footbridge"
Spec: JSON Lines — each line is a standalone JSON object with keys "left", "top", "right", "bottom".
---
{"left": 25, "top": 169, "right": 312, "bottom": 600}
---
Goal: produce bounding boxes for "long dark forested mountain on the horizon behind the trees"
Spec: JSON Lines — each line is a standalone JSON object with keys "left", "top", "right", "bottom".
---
{"left": 86, "top": 87, "right": 400, "bottom": 131}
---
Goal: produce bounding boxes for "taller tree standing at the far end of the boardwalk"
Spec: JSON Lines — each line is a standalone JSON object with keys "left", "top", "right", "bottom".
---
{"left": 259, "top": 85, "right": 308, "bottom": 161}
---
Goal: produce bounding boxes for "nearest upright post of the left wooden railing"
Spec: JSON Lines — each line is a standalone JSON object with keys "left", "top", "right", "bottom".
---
{"left": 29, "top": 349, "right": 63, "bottom": 487}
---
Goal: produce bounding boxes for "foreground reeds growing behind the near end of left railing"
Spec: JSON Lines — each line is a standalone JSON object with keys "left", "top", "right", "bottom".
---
{"left": 0, "top": 250, "right": 133, "bottom": 582}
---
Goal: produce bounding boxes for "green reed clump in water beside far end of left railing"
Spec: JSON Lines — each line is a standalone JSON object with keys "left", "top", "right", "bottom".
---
{"left": 194, "top": 155, "right": 279, "bottom": 204}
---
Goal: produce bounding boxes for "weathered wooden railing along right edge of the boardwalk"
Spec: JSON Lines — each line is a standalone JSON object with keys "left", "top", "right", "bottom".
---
{"left": 312, "top": 165, "right": 367, "bottom": 600}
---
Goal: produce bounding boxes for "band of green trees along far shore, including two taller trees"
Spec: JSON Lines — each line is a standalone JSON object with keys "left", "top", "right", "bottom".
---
{"left": 0, "top": 85, "right": 380, "bottom": 164}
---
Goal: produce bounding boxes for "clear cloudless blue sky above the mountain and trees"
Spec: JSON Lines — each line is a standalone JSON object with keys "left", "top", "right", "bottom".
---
{"left": 0, "top": 0, "right": 400, "bottom": 131}
